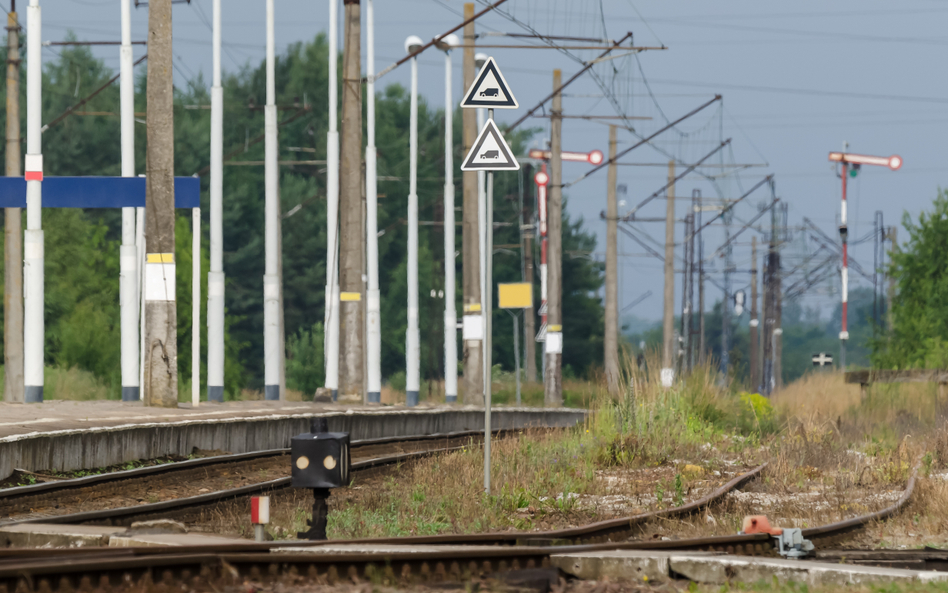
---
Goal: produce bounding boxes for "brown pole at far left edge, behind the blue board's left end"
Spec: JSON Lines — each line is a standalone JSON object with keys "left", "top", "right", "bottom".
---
{"left": 3, "top": 0, "right": 24, "bottom": 402}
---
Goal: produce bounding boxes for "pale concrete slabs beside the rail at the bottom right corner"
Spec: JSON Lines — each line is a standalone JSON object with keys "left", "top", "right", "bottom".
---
{"left": 550, "top": 550, "right": 948, "bottom": 586}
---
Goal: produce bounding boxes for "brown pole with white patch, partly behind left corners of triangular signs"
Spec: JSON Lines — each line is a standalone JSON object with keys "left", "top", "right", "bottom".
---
{"left": 461, "top": 3, "right": 484, "bottom": 404}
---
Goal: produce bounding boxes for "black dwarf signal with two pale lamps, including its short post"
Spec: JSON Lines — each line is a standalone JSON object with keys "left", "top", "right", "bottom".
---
{"left": 290, "top": 418, "right": 351, "bottom": 540}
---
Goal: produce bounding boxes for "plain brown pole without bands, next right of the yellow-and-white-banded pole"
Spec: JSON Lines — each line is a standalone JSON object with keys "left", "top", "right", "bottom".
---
{"left": 603, "top": 126, "right": 619, "bottom": 395}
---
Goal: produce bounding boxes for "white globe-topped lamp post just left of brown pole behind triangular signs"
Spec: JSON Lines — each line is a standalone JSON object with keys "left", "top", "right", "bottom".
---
{"left": 442, "top": 35, "right": 462, "bottom": 403}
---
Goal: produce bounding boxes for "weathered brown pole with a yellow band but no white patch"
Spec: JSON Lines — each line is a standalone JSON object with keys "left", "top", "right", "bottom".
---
{"left": 339, "top": 0, "right": 365, "bottom": 401}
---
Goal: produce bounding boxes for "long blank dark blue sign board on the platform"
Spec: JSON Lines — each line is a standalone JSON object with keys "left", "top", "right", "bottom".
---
{"left": 0, "top": 177, "right": 201, "bottom": 208}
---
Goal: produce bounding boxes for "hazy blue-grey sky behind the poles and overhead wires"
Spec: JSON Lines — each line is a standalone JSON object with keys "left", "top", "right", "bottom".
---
{"left": 37, "top": 0, "right": 948, "bottom": 319}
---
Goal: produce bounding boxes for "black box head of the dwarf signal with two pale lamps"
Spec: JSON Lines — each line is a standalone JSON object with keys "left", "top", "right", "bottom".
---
{"left": 290, "top": 432, "right": 351, "bottom": 488}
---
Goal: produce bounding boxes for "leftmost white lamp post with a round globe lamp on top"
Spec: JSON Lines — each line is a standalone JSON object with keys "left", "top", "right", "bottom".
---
{"left": 405, "top": 35, "right": 423, "bottom": 406}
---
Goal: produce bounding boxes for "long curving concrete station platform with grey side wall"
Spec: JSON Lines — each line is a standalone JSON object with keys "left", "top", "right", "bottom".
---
{"left": 0, "top": 401, "right": 586, "bottom": 479}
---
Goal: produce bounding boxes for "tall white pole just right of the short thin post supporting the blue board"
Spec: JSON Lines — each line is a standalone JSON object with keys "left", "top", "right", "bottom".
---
{"left": 207, "top": 0, "right": 224, "bottom": 402}
